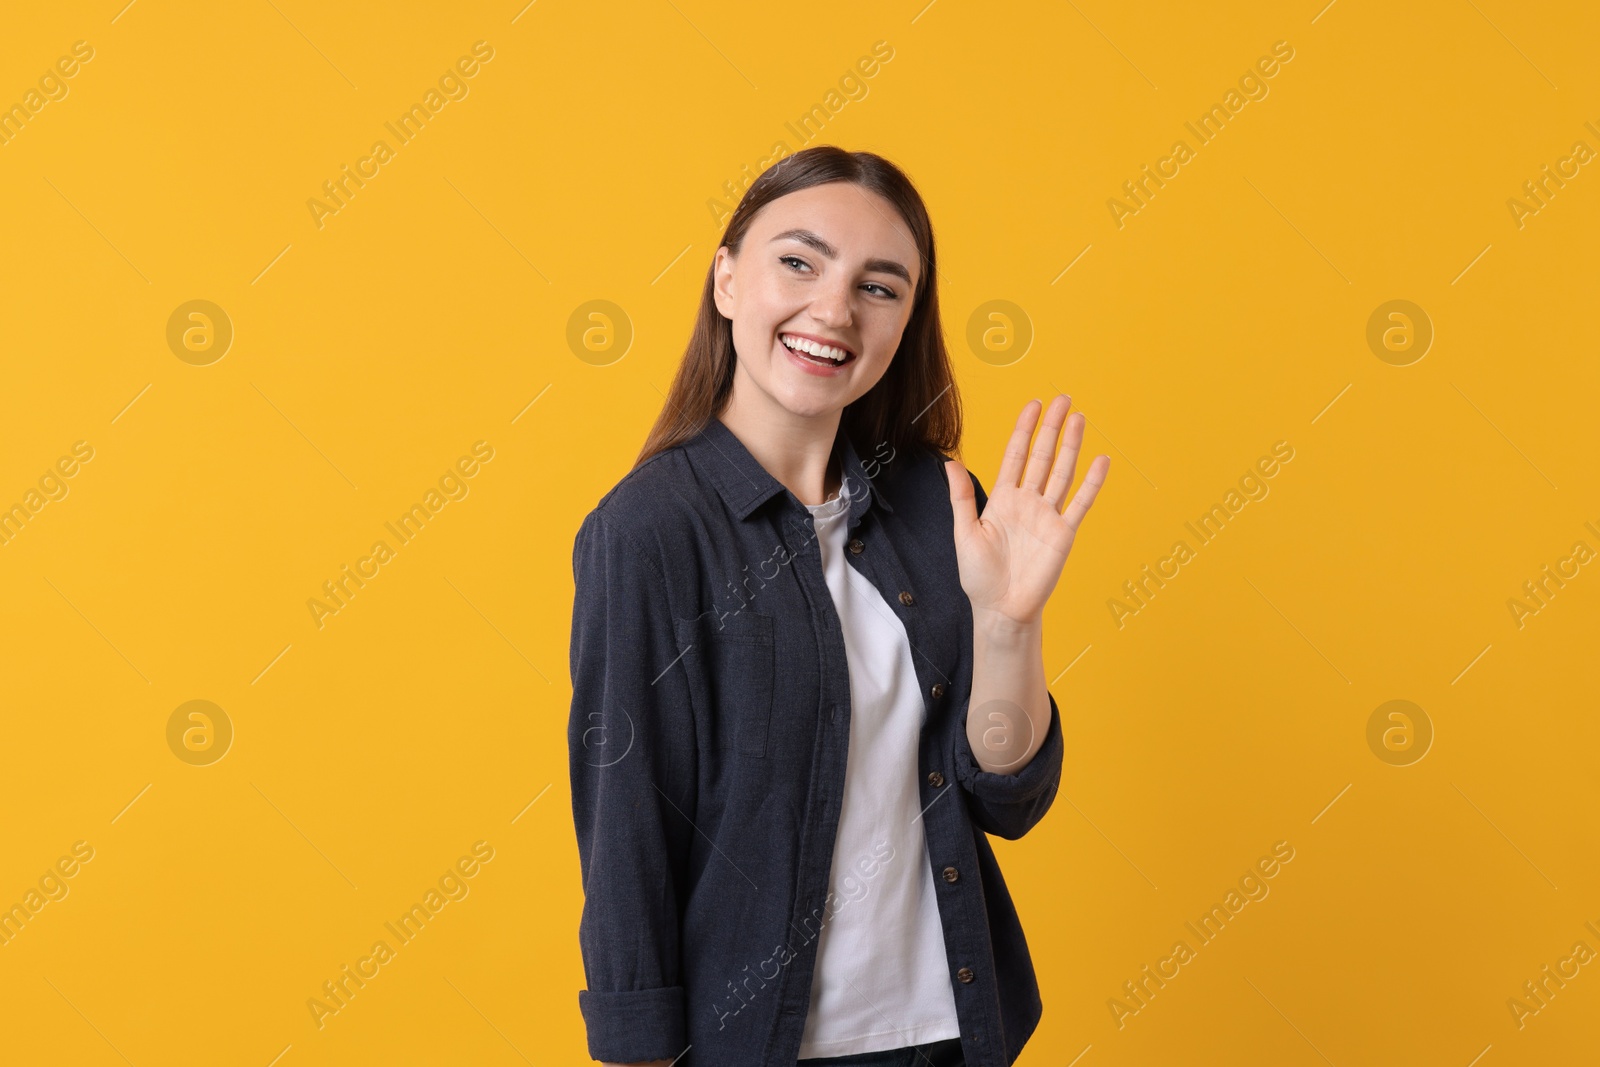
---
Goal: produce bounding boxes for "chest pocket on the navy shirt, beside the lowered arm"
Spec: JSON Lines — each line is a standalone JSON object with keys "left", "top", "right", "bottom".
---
{"left": 677, "top": 609, "right": 774, "bottom": 757}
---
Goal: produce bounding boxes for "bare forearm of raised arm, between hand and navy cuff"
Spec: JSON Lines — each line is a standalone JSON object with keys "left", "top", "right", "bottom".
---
{"left": 966, "top": 611, "right": 1051, "bottom": 774}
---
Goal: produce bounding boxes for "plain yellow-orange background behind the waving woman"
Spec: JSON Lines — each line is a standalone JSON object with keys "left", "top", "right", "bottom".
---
{"left": 0, "top": 0, "right": 1600, "bottom": 1067}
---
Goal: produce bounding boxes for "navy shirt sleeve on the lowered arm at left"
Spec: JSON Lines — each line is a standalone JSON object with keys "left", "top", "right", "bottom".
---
{"left": 566, "top": 509, "right": 696, "bottom": 1062}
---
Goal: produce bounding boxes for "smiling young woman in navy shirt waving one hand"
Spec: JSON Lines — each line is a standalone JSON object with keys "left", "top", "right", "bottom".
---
{"left": 568, "top": 146, "right": 1110, "bottom": 1067}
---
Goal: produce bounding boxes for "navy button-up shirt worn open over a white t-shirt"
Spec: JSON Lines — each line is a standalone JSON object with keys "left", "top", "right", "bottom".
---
{"left": 568, "top": 418, "right": 1062, "bottom": 1067}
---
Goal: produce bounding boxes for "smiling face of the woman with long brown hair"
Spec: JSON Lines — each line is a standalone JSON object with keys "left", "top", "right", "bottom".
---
{"left": 714, "top": 181, "right": 922, "bottom": 419}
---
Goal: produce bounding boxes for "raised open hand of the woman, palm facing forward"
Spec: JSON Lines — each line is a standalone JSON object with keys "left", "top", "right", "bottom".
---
{"left": 944, "top": 395, "right": 1110, "bottom": 625}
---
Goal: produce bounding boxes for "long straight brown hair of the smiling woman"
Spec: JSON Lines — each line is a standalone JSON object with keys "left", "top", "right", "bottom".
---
{"left": 634, "top": 144, "right": 962, "bottom": 467}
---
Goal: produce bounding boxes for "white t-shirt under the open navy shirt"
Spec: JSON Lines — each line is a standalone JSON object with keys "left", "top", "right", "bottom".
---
{"left": 800, "top": 476, "right": 960, "bottom": 1059}
